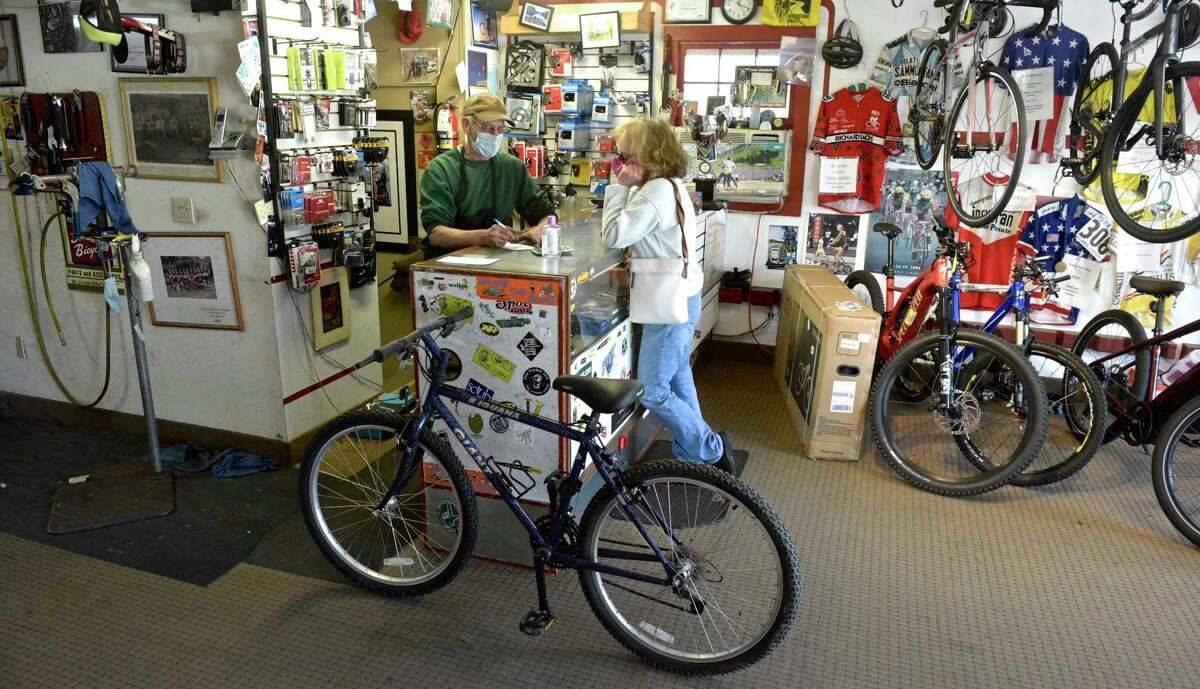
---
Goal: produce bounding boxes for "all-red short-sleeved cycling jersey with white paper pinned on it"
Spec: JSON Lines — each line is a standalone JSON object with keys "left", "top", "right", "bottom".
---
{"left": 810, "top": 88, "right": 904, "bottom": 214}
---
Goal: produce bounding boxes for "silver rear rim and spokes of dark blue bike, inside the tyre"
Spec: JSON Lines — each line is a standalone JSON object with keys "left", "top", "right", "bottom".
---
{"left": 583, "top": 477, "right": 786, "bottom": 663}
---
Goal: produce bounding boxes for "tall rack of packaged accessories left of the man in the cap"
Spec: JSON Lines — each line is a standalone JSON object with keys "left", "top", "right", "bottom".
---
{"left": 244, "top": 0, "right": 378, "bottom": 276}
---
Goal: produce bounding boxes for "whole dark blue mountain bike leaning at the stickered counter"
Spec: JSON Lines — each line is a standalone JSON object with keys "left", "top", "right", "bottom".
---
{"left": 300, "top": 307, "right": 800, "bottom": 675}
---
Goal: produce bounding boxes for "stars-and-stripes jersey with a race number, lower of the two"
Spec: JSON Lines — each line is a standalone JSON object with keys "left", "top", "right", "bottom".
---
{"left": 1018, "top": 196, "right": 1112, "bottom": 325}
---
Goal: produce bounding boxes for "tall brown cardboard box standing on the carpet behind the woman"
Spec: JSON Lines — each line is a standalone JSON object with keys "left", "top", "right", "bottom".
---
{"left": 775, "top": 265, "right": 880, "bottom": 461}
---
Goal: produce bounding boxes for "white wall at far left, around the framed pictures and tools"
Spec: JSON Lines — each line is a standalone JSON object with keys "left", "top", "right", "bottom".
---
{"left": 0, "top": 5, "right": 286, "bottom": 438}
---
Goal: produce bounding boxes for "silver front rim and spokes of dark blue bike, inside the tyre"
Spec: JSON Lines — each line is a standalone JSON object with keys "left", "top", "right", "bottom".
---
{"left": 307, "top": 424, "right": 463, "bottom": 586}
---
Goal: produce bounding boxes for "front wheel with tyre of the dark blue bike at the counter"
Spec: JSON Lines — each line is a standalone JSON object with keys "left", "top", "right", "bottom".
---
{"left": 300, "top": 409, "right": 478, "bottom": 597}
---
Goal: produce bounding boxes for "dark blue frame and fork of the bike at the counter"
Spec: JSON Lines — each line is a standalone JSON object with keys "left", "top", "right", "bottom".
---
{"left": 379, "top": 331, "right": 679, "bottom": 586}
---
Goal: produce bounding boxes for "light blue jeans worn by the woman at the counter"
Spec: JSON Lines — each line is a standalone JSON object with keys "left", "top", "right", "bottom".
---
{"left": 637, "top": 294, "right": 724, "bottom": 465}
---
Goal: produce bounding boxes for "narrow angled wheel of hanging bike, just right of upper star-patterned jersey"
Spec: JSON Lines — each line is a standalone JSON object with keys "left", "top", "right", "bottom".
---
{"left": 1068, "top": 43, "right": 1121, "bottom": 186}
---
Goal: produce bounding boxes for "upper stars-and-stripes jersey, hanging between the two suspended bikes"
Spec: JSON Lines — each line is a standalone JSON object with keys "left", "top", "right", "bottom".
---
{"left": 1000, "top": 24, "right": 1092, "bottom": 156}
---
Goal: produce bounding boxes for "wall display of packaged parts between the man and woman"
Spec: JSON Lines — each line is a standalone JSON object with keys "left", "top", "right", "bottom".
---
{"left": 504, "top": 32, "right": 655, "bottom": 188}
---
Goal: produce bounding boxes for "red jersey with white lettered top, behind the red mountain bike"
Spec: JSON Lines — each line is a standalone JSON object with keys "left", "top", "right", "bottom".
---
{"left": 946, "top": 173, "right": 1037, "bottom": 308}
